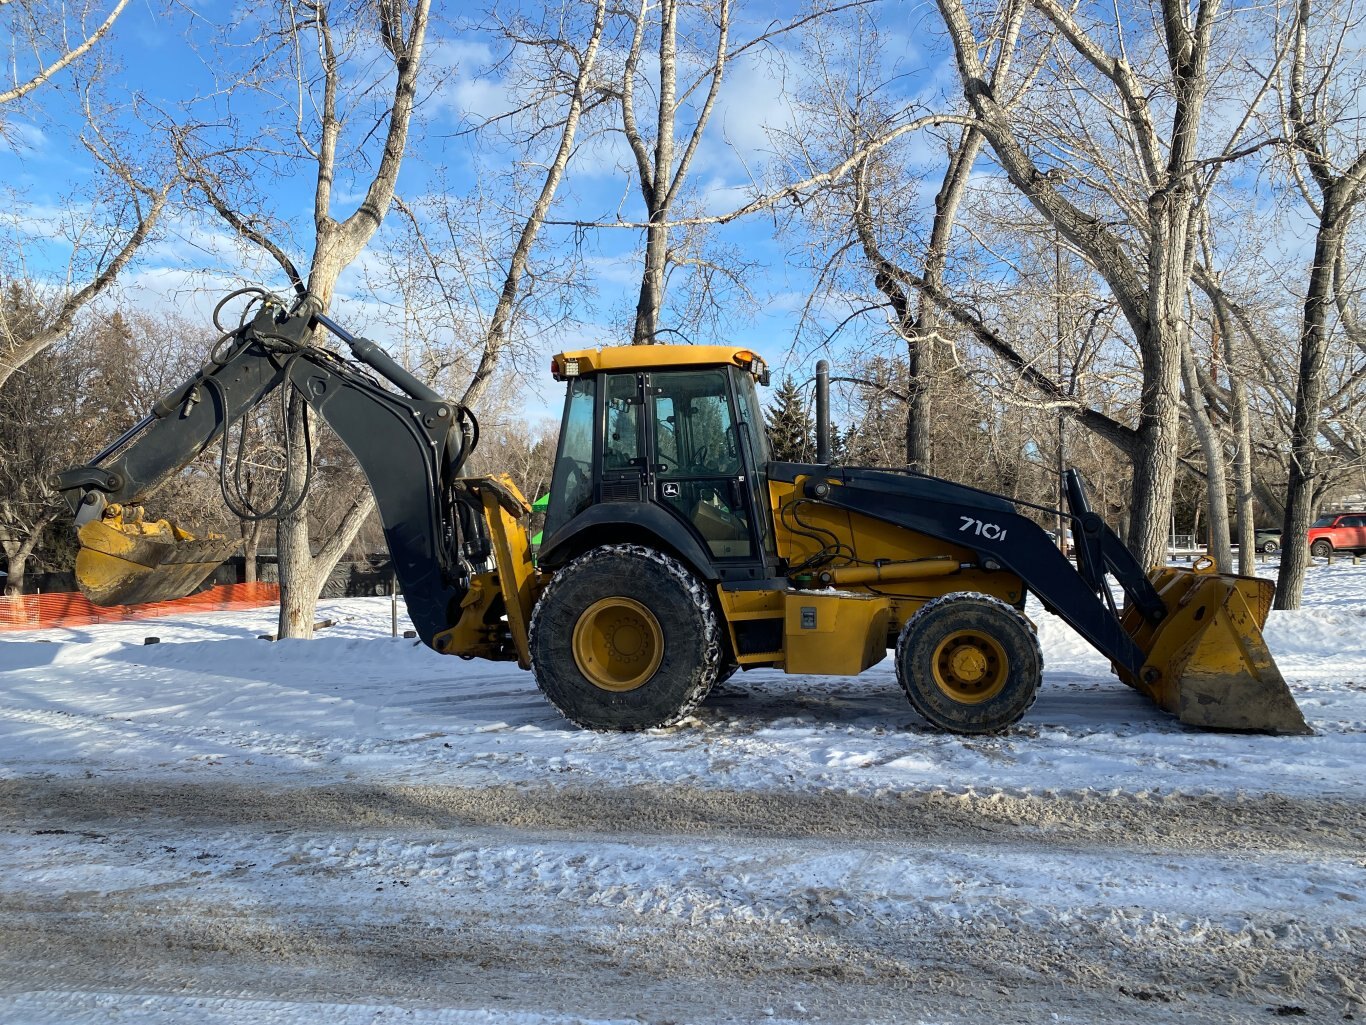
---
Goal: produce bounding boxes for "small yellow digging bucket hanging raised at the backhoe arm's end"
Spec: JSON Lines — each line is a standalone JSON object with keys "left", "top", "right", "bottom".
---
{"left": 76, "top": 506, "right": 238, "bottom": 605}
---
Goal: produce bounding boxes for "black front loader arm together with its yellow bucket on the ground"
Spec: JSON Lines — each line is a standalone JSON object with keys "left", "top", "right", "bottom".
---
{"left": 803, "top": 467, "right": 1311, "bottom": 734}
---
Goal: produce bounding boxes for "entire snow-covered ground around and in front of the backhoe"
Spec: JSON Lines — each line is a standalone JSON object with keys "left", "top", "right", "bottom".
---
{"left": 0, "top": 562, "right": 1366, "bottom": 1025}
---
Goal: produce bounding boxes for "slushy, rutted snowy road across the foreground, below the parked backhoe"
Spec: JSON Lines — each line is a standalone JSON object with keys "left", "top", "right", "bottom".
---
{"left": 8, "top": 780, "right": 1366, "bottom": 1022}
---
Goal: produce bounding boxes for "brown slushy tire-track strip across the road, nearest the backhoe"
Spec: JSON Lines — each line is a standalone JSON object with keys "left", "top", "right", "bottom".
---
{"left": 0, "top": 776, "right": 1366, "bottom": 857}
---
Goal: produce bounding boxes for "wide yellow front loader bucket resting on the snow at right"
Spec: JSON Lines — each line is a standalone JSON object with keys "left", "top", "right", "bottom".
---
{"left": 1119, "top": 560, "right": 1313, "bottom": 734}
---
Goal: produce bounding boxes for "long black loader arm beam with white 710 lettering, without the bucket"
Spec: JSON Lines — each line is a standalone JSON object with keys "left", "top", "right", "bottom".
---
{"left": 807, "top": 467, "right": 1143, "bottom": 674}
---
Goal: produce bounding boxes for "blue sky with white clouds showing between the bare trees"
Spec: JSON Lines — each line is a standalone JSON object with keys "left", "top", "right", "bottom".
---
{"left": 0, "top": 0, "right": 1344, "bottom": 434}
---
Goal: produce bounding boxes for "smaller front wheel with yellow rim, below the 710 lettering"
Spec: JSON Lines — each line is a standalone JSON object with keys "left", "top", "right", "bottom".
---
{"left": 896, "top": 593, "right": 1044, "bottom": 734}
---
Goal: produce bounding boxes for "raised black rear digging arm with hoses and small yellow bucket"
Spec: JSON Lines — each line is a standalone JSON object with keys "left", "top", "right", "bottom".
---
{"left": 52, "top": 299, "right": 508, "bottom": 644}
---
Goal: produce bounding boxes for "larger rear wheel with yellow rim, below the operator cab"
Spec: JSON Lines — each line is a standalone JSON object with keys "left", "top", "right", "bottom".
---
{"left": 530, "top": 544, "right": 721, "bottom": 730}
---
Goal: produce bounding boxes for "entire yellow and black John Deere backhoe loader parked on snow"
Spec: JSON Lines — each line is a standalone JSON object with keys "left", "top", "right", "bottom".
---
{"left": 53, "top": 294, "right": 1309, "bottom": 734}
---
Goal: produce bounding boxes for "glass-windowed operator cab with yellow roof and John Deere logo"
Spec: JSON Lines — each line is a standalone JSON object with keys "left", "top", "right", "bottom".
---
{"left": 542, "top": 346, "right": 776, "bottom": 579}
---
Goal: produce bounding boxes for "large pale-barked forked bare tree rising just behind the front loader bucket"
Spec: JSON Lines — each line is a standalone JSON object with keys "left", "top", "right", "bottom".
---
{"left": 938, "top": 0, "right": 1251, "bottom": 563}
